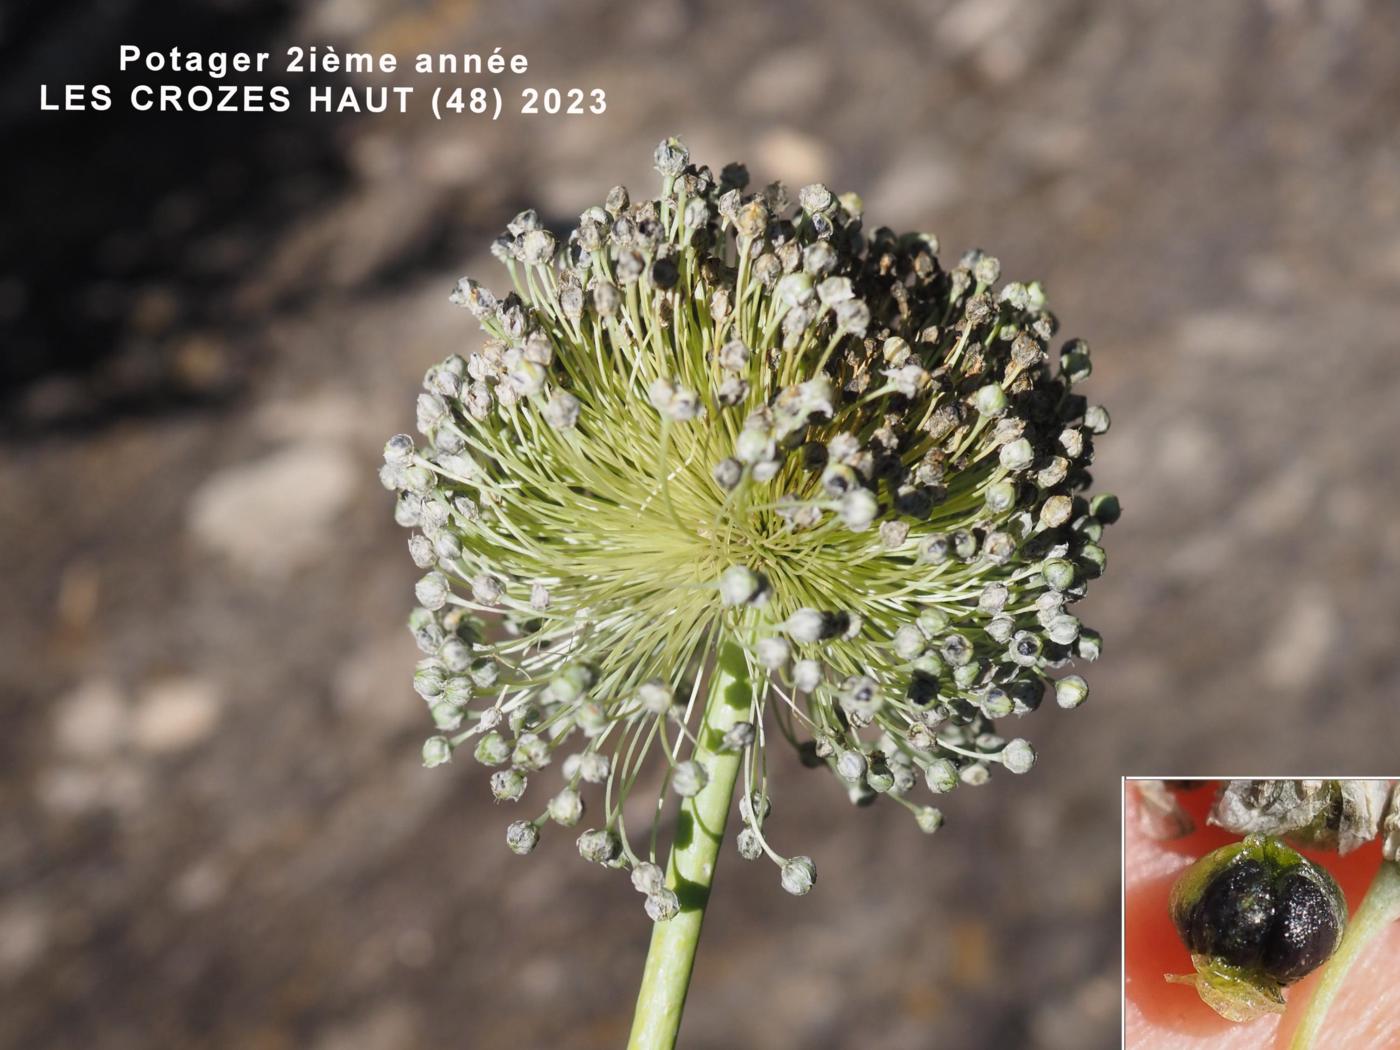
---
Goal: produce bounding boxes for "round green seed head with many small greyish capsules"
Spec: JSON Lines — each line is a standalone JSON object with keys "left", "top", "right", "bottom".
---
{"left": 382, "top": 139, "right": 1117, "bottom": 921}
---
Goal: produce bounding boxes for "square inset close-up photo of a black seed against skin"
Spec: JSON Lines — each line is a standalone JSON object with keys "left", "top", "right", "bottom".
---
{"left": 1123, "top": 777, "right": 1400, "bottom": 1050}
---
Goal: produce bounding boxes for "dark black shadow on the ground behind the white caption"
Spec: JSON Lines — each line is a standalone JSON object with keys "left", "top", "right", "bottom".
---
{"left": 0, "top": 0, "right": 346, "bottom": 434}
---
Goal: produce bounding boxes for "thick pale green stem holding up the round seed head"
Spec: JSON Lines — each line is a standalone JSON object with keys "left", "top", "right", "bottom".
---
{"left": 627, "top": 641, "right": 753, "bottom": 1050}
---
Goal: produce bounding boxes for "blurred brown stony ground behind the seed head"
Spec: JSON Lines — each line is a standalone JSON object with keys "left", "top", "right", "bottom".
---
{"left": 0, "top": 0, "right": 1400, "bottom": 1050}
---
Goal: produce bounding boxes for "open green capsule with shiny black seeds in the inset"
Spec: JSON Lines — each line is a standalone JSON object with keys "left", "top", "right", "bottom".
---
{"left": 1166, "top": 834, "right": 1347, "bottom": 1021}
